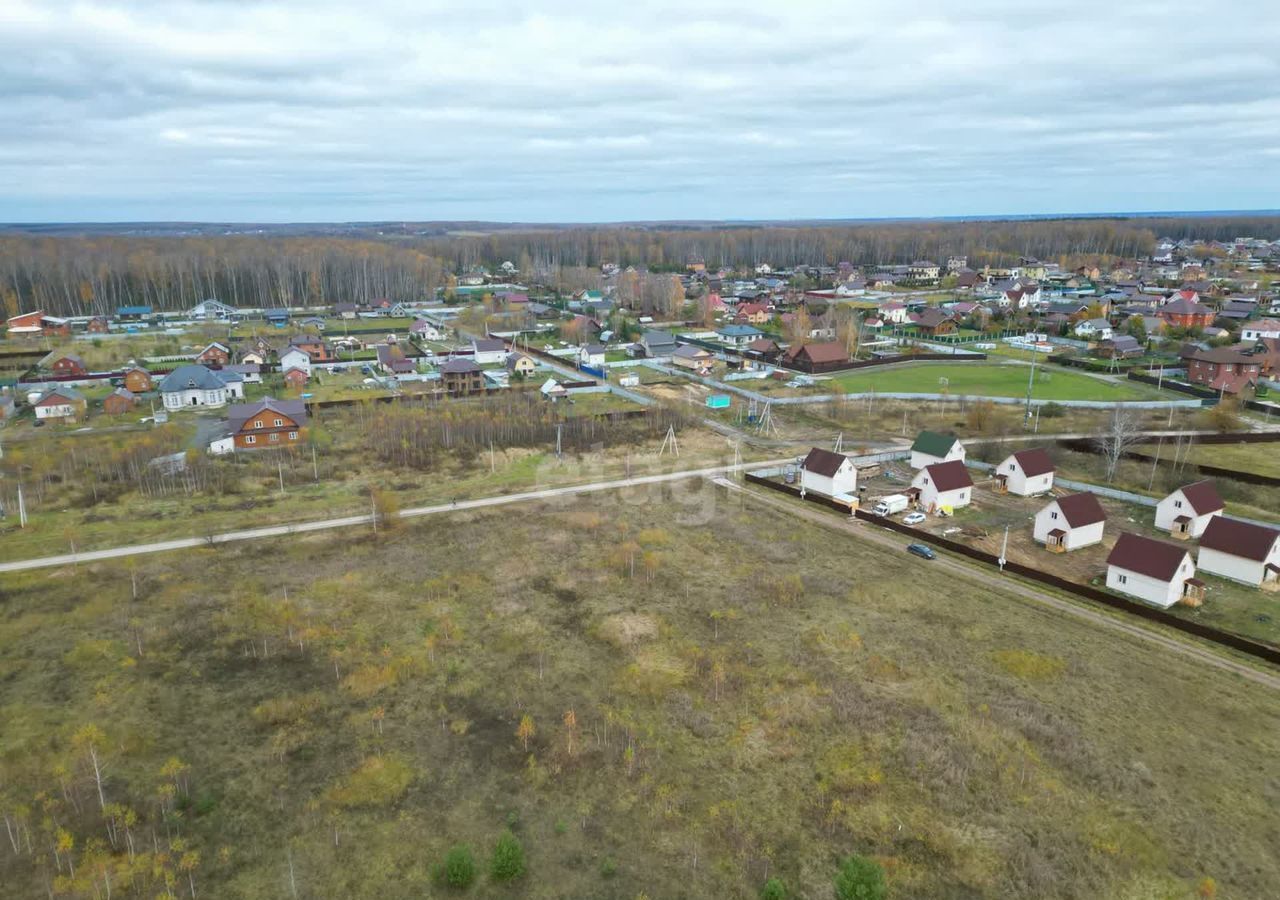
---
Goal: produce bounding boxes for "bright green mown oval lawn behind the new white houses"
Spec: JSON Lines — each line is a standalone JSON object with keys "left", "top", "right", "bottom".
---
{"left": 818, "top": 362, "right": 1161, "bottom": 401}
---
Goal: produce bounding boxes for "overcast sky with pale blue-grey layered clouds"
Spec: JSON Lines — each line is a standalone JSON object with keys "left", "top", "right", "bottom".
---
{"left": 0, "top": 0, "right": 1280, "bottom": 221}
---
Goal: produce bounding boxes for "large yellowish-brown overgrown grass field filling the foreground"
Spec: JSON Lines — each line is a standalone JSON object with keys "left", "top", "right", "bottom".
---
{"left": 0, "top": 496, "right": 1280, "bottom": 900}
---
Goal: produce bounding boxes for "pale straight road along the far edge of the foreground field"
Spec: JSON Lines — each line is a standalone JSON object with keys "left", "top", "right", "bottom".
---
{"left": 0, "top": 456, "right": 795, "bottom": 572}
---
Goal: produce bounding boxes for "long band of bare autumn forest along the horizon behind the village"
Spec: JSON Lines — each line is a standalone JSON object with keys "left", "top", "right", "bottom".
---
{"left": 0, "top": 215, "right": 1280, "bottom": 315}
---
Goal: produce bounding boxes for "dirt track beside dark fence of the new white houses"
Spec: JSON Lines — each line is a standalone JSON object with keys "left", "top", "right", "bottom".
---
{"left": 716, "top": 479, "right": 1280, "bottom": 690}
